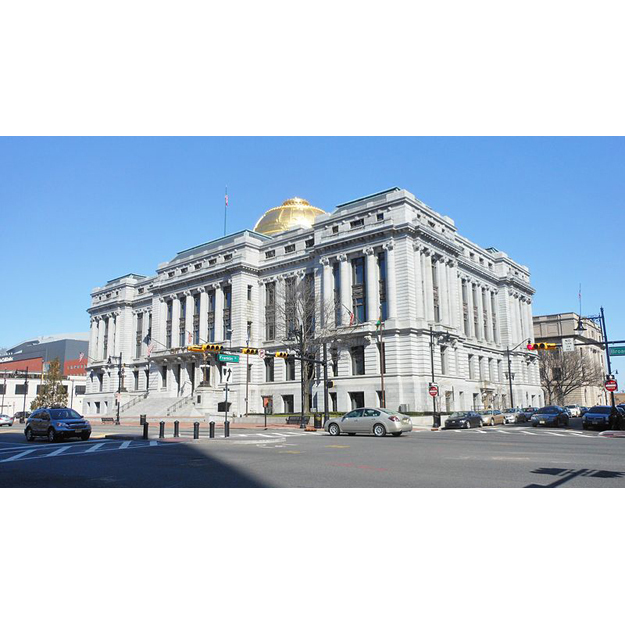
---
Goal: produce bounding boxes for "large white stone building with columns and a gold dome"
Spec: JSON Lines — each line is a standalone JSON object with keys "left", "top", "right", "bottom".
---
{"left": 85, "top": 188, "right": 543, "bottom": 416}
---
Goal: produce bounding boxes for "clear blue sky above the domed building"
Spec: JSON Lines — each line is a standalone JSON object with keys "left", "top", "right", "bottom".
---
{"left": 0, "top": 136, "right": 625, "bottom": 379}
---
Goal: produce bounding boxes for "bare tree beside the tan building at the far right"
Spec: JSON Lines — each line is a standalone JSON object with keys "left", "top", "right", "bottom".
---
{"left": 540, "top": 349, "right": 603, "bottom": 404}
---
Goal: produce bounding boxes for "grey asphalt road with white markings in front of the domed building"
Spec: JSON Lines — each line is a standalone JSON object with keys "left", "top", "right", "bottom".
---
{"left": 0, "top": 420, "right": 625, "bottom": 488}
